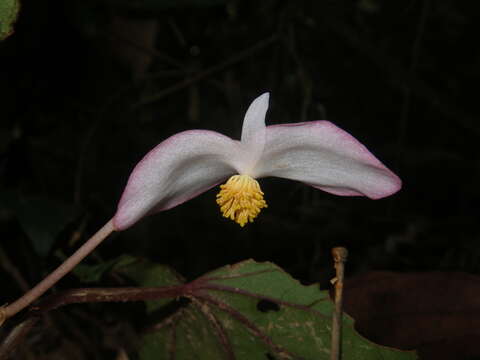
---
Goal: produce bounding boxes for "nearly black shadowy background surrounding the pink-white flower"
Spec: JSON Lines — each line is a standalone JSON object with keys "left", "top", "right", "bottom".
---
{"left": 0, "top": 0, "right": 480, "bottom": 358}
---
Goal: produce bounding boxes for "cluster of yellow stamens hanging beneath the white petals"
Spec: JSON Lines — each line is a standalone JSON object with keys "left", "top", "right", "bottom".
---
{"left": 217, "top": 175, "right": 267, "bottom": 227}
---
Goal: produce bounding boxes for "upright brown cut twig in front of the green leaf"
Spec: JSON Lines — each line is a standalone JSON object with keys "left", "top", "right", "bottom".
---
{"left": 330, "top": 247, "right": 348, "bottom": 360}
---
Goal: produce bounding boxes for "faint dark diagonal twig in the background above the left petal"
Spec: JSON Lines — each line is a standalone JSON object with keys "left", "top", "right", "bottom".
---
{"left": 133, "top": 35, "right": 278, "bottom": 109}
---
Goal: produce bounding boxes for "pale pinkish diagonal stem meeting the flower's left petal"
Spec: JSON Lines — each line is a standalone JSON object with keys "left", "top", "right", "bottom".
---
{"left": 0, "top": 220, "right": 115, "bottom": 325}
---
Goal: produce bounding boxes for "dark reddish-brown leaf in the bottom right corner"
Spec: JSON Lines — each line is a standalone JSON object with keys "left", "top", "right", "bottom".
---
{"left": 344, "top": 272, "right": 480, "bottom": 360}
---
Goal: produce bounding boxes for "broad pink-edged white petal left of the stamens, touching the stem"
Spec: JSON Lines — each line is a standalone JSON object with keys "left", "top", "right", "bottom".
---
{"left": 113, "top": 130, "right": 243, "bottom": 230}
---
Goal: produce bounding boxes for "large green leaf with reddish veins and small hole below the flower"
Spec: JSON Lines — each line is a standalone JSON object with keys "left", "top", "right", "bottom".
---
{"left": 117, "top": 260, "right": 415, "bottom": 360}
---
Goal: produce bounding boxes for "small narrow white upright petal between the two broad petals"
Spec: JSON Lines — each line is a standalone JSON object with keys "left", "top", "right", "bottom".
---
{"left": 241, "top": 92, "right": 270, "bottom": 174}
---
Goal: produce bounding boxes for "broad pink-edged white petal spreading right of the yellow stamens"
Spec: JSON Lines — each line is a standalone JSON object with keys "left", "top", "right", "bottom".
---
{"left": 252, "top": 121, "right": 401, "bottom": 199}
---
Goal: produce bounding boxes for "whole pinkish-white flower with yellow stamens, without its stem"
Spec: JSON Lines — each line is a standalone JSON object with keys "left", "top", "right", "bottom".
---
{"left": 113, "top": 93, "right": 401, "bottom": 230}
